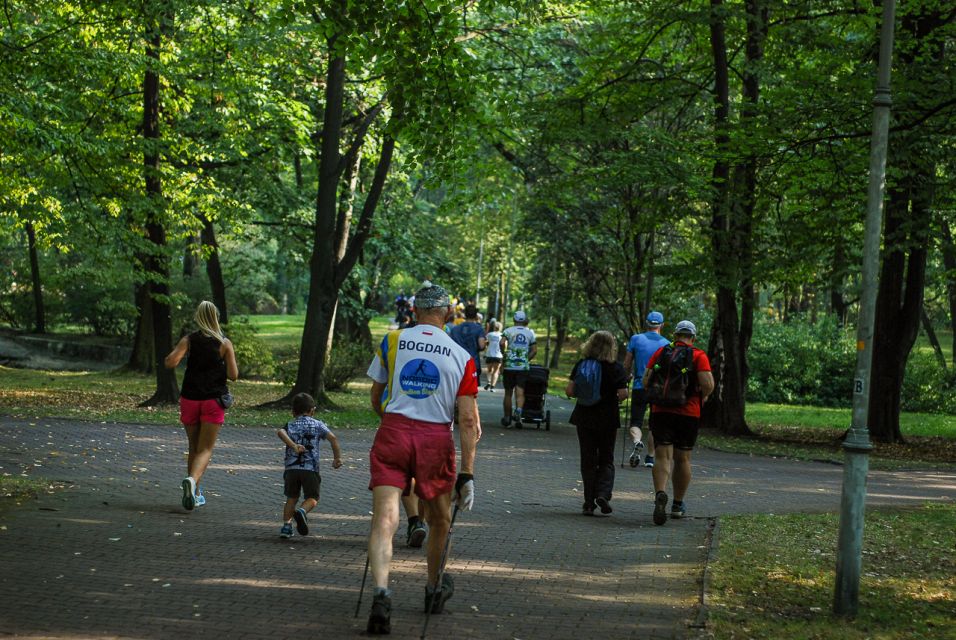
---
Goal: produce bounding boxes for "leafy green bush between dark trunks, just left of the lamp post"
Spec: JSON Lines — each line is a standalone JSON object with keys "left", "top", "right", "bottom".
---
{"left": 747, "top": 316, "right": 856, "bottom": 407}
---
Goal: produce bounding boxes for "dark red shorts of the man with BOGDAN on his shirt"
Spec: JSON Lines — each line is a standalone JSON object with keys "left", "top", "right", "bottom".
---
{"left": 368, "top": 413, "right": 456, "bottom": 500}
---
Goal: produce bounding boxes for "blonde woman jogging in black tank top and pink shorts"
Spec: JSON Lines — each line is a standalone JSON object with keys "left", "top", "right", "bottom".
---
{"left": 166, "top": 300, "right": 239, "bottom": 511}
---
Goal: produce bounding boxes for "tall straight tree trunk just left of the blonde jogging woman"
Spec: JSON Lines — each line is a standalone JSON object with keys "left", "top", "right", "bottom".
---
{"left": 141, "top": 8, "right": 179, "bottom": 406}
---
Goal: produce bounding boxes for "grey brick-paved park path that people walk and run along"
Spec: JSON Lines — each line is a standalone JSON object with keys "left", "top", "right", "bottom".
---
{"left": 0, "top": 393, "right": 956, "bottom": 640}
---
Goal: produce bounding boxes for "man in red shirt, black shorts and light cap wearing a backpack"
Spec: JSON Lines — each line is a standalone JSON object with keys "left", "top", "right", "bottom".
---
{"left": 643, "top": 320, "right": 714, "bottom": 525}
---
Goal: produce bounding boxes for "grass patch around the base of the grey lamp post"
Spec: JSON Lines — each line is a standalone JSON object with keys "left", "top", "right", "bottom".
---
{"left": 708, "top": 504, "right": 956, "bottom": 640}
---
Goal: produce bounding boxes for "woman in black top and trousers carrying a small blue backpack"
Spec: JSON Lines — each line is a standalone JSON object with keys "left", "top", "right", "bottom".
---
{"left": 564, "top": 331, "right": 628, "bottom": 516}
